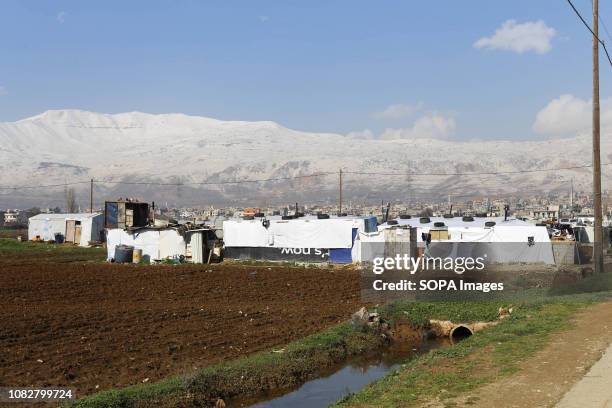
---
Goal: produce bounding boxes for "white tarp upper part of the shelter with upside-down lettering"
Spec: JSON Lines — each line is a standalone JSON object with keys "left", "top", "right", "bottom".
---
{"left": 223, "top": 217, "right": 365, "bottom": 248}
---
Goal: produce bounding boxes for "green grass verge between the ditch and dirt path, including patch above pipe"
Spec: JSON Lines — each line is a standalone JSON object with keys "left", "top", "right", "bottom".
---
{"left": 337, "top": 292, "right": 610, "bottom": 407}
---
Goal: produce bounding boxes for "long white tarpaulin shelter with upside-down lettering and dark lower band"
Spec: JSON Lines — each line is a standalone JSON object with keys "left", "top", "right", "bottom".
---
{"left": 223, "top": 216, "right": 376, "bottom": 263}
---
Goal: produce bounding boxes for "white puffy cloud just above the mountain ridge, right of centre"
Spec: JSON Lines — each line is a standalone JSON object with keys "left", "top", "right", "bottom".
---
{"left": 380, "top": 114, "right": 457, "bottom": 139}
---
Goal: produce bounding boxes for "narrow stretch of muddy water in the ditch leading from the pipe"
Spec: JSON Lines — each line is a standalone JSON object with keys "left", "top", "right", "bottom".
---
{"left": 233, "top": 339, "right": 450, "bottom": 408}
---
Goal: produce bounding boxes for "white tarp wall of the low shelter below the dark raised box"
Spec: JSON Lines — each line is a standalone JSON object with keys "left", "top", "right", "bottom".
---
{"left": 106, "top": 229, "right": 186, "bottom": 261}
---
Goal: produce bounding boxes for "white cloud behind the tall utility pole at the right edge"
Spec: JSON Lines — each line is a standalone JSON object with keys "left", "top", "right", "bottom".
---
{"left": 533, "top": 94, "right": 612, "bottom": 137}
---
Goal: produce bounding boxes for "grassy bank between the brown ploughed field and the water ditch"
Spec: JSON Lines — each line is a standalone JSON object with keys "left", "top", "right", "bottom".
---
{"left": 75, "top": 323, "right": 383, "bottom": 407}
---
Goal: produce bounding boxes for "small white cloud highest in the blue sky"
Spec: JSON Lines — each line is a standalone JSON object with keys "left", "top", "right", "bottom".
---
{"left": 474, "top": 20, "right": 557, "bottom": 54}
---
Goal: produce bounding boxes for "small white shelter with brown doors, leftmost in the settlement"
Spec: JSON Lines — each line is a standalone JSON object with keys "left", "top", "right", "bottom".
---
{"left": 28, "top": 213, "right": 104, "bottom": 247}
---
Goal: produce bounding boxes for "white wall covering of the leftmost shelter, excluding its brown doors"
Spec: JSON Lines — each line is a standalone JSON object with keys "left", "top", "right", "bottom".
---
{"left": 28, "top": 213, "right": 104, "bottom": 247}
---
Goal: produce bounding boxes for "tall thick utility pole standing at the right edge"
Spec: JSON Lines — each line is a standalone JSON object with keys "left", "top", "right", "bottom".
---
{"left": 593, "top": 0, "right": 603, "bottom": 273}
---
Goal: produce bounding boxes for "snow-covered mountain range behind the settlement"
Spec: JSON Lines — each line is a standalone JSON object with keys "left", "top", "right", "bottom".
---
{"left": 0, "top": 110, "right": 612, "bottom": 207}
